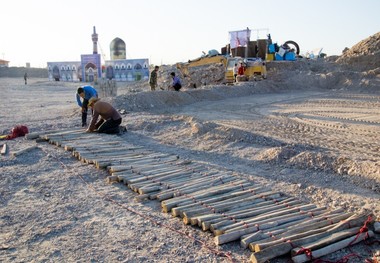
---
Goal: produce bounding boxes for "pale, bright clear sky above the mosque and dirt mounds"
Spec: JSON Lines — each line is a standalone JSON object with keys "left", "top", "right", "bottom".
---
{"left": 0, "top": 0, "right": 380, "bottom": 67}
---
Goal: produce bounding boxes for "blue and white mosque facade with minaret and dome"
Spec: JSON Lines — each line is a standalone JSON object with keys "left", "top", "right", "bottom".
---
{"left": 47, "top": 26, "right": 149, "bottom": 82}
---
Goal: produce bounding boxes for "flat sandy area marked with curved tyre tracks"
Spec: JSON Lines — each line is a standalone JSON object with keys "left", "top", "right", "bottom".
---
{"left": 174, "top": 92, "right": 380, "bottom": 188}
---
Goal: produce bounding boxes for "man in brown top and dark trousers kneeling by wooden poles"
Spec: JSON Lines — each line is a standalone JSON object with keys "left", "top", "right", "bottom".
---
{"left": 86, "top": 97, "right": 122, "bottom": 134}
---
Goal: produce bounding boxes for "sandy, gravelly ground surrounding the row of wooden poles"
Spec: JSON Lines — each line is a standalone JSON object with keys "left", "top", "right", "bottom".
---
{"left": 0, "top": 59, "right": 380, "bottom": 262}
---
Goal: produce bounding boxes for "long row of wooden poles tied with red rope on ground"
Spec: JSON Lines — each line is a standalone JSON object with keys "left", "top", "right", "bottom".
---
{"left": 29, "top": 129, "right": 374, "bottom": 262}
